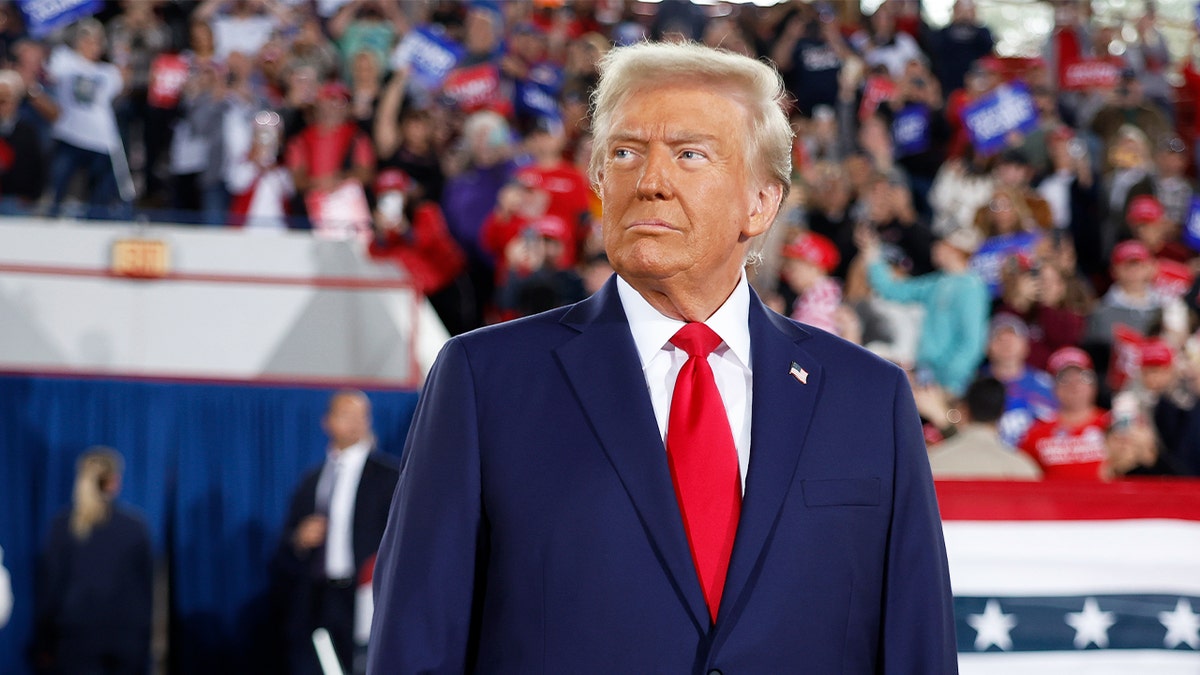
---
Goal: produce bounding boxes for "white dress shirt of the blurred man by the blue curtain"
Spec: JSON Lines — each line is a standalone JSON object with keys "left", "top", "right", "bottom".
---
{"left": 317, "top": 438, "right": 372, "bottom": 579}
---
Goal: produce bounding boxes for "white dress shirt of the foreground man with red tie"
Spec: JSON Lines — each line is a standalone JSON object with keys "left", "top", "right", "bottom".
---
{"left": 617, "top": 275, "right": 752, "bottom": 494}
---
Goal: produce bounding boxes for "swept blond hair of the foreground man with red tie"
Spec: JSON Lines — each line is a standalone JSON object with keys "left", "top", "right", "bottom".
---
{"left": 588, "top": 42, "right": 792, "bottom": 196}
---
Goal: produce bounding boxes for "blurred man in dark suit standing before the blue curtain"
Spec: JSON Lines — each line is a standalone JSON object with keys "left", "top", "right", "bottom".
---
{"left": 276, "top": 390, "right": 398, "bottom": 674}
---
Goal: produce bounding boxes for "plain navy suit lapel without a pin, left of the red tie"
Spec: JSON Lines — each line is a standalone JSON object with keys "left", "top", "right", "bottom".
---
{"left": 554, "top": 276, "right": 708, "bottom": 632}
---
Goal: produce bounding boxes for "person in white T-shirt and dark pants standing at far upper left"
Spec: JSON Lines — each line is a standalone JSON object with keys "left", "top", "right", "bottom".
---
{"left": 46, "top": 19, "right": 133, "bottom": 217}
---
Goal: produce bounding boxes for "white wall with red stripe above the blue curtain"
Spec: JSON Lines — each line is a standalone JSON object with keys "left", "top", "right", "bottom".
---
{"left": 0, "top": 219, "right": 446, "bottom": 386}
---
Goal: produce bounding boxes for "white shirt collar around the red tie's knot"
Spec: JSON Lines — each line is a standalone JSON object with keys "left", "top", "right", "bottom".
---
{"left": 617, "top": 274, "right": 750, "bottom": 370}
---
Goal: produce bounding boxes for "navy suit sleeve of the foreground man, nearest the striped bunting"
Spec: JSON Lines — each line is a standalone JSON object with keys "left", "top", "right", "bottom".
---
{"left": 880, "top": 372, "right": 958, "bottom": 675}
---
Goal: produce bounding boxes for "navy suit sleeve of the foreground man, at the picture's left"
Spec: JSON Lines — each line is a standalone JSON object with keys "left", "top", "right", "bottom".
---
{"left": 367, "top": 340, "right": 486, "bottom": 675}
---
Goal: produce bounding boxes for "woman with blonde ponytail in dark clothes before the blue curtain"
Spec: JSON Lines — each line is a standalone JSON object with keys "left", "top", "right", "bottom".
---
{"left": 34, "top": 447, "right": 154, "bottom": 675}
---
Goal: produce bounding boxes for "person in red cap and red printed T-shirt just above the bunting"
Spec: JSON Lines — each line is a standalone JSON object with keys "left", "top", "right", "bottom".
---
{"left": 1020, "top": 347, "right": 1109, "bottom": 480}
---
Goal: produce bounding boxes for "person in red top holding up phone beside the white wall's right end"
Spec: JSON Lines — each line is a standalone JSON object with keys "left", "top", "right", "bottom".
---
{"left": 370, "top": 169, "right": 472, "bottom": 335}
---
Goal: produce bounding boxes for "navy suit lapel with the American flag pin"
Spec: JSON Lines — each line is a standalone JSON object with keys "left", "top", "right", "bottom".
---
{"left": 718, "top": 294, "right": 822, "bottom": 628}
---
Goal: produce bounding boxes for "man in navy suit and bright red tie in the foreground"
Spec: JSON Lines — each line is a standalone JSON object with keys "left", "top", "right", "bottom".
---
{"left": 368, "top": 43, "right": 956, "bottom": 675}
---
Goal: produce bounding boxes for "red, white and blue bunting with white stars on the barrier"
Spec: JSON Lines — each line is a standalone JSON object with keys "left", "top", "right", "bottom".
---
{"left": 937, "top": 480, "right": 1200, "bottom": 675}
